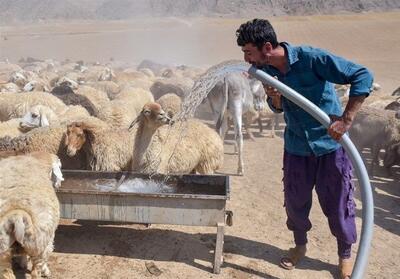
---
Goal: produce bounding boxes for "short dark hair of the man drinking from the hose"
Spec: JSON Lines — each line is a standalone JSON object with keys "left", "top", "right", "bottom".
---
{"left": 236, "top": 18, "right": 278, "bottom": 49}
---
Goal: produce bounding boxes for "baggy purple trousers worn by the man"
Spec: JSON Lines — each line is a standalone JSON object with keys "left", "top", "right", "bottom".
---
{"left": 283, "top": 147, "right": 357, "bottom": 258}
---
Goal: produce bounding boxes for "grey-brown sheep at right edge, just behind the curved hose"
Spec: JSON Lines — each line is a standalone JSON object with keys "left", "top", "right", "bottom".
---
{"left": 349, "top": 107, "right": 400, "bottom": 175}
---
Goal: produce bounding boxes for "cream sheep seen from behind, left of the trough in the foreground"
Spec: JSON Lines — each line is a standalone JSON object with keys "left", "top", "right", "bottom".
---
{"left": 0, "top": 152, "right": 63, "bottom": 279}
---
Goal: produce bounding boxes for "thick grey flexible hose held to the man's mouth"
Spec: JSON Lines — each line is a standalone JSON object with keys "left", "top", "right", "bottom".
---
{"left": 248, "top": 66, "right": 374, "bottom": 279}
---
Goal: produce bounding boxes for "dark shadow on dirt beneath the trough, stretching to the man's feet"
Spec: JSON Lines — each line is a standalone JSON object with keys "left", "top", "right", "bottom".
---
{"left": 55, "top": 223, "right": 336, "bottom": 278}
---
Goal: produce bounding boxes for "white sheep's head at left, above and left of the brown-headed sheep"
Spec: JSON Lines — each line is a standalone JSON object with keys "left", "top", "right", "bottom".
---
{"left": 19, "top": 105, "right": 57, "bottom": 130}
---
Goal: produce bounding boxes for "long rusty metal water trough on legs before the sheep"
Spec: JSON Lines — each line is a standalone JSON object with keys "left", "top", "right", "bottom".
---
{"left": 57, "top": 170, "right": 232, "bottom": 273}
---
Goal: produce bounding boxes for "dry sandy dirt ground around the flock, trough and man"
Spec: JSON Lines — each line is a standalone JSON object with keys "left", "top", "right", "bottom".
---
{"left": 0, "top": 13, "right": 400, "bottom": 279}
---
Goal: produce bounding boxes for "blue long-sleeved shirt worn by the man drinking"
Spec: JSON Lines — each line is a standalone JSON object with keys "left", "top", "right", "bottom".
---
{"left": 262, "top": 43, "right": 373, "bottom": 156}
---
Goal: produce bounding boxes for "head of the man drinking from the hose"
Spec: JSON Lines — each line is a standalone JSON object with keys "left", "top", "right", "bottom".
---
{"left": 236, "top": 18, "right": 279, "bottom": 67}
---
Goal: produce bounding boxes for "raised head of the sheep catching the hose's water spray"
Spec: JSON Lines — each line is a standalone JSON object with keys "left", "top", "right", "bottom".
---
{"left": 129, "top": 103, "right": 171, "bottom": 129}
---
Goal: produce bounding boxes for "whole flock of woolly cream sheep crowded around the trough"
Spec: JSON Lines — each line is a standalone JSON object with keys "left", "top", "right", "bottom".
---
{"left": 0, "top": 59, "right": 400, "bottom": 278}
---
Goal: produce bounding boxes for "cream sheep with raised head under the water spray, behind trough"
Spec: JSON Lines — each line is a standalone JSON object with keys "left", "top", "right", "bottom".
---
{"left": 129, "top": 103, "right": 224, "bottom": 174}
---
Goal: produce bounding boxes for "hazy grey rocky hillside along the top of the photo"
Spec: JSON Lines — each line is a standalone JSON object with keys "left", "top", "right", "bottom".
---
{"left": 0, "top": 0, "right": 400, "bottom": 24}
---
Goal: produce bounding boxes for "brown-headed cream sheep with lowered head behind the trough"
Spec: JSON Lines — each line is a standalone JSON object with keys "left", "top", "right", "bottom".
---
{"left": 65, "top": 122, "right": 134, "bottom": 171}
